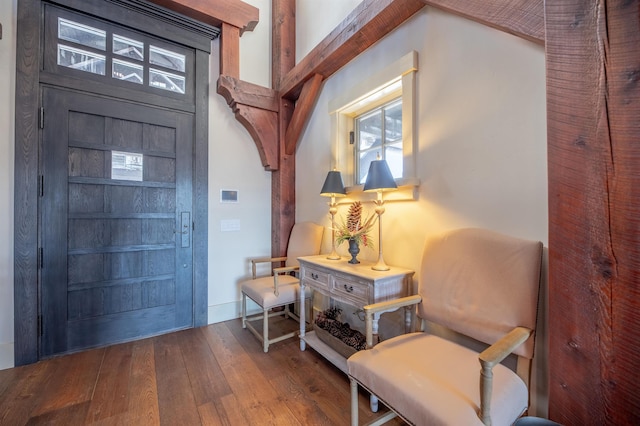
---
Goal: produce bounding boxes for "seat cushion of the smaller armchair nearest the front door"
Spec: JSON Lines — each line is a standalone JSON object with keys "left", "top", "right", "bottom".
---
{"left": 240, "top": 275, "right": 308, "bottom": 309}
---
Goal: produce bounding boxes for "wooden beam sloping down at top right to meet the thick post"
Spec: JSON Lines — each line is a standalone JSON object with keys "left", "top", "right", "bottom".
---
{"left": 424, "top": 0, "right": 544, "bottom": 44}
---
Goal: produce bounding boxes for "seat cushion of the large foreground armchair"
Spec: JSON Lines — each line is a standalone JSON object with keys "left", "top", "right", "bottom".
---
{"left": 347, "top": 333, "right": 528, "bottom": 425}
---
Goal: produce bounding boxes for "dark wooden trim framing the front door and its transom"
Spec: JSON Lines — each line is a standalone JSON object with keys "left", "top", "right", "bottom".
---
{"left": 14, "top": 0, "right": 214, "bottom": 366}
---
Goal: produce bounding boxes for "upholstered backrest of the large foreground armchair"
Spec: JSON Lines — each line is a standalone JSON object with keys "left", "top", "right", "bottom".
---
{"left": 418, "top": 228, "right": 542, "bottom": 359}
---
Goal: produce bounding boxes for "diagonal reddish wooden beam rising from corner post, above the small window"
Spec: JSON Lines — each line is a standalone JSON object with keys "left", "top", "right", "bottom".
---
{"left": 279, "top": 0, "right": 424, "bottom": 100}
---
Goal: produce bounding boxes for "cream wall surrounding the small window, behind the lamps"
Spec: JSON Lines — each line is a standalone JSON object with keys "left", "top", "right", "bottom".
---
{"left": 296, "top": 5, "right": 548, "bottom": 416}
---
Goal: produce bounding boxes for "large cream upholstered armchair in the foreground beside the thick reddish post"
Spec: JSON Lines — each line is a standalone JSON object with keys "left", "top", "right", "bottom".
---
{"left": 347, "top": 229, "right": 542, "bottom": 425}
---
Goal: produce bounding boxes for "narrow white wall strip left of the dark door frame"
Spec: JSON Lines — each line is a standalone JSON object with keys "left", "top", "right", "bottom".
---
{"left": 0, "top": 0, "right": 17, "bottom": 369}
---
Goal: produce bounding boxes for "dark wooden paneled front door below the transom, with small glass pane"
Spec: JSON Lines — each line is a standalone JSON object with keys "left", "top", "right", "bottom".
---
{"left": 40, "top": 88, "right": 193, "bottom": 357}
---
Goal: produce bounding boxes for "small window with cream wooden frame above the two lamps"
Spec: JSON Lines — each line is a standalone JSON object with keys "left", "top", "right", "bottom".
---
{"left": 329, "top": 51, "right": 419, "bottom": 197}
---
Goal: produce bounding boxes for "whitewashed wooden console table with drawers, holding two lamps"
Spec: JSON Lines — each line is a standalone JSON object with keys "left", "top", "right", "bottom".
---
{"left": 298, "top": 255, "right": 414, "bottom": 411}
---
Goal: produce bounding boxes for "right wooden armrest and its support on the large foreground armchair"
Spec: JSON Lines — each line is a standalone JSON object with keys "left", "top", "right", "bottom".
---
{"left": 478, "top": 327, "right": 532, "bottom": 425}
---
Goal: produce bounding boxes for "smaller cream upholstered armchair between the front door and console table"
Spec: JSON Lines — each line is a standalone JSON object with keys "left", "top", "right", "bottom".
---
{"left": 240, "top": 222, "right": 324, "bottom": 352}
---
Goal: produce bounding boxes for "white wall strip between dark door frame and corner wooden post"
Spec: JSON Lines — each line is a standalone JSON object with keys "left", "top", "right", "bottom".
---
{"left": 209, "top": 0, "right": 271, "bottom": 323}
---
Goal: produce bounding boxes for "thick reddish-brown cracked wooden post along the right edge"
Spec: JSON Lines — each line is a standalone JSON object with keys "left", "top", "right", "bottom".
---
{"left": 545, "top": 0, "right": 640, "bottom": 425}
